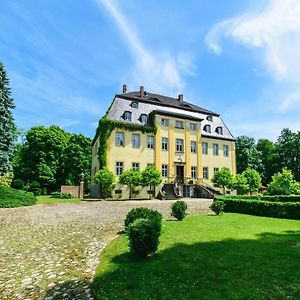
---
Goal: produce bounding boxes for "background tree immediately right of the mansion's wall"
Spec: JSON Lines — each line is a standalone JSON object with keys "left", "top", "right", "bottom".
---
{"left": 236, "top": 136, "right": 263, "bottom": 173}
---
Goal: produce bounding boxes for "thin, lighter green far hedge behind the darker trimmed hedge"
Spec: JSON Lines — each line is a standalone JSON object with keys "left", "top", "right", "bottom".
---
{"left": 215, "top": 195, "right": 300, "bottom": 202}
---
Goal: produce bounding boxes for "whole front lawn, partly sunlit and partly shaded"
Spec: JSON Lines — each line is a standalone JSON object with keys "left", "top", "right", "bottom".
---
{"left": 92, "top": 213, "right": 300, "bottom": 299}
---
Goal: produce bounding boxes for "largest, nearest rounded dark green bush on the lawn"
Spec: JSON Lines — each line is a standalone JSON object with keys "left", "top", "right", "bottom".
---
{"left": 128, "top": 218, "right": 160, "bottom": 257}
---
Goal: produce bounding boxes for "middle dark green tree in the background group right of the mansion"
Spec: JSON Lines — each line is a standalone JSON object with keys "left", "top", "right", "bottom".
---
{"left": 256, "top": 139, "right": 280, "bottom": 185}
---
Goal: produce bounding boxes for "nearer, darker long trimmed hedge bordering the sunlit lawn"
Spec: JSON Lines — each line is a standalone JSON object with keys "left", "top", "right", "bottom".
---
{"left": 217, "top": 196, "right": 300, "bottom": 220}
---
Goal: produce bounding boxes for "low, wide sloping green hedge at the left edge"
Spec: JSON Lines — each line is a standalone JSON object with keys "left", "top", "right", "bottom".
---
{"left": 0, "top": 185, "right": 36, "bottom": 208}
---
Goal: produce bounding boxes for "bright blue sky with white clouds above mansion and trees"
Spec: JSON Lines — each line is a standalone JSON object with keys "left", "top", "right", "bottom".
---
{"left": 0, "top": 0, "right": 300, "bottom": 140}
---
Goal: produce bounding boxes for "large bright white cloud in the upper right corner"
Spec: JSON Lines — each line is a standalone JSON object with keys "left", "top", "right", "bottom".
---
{"left": 205, "top": 0, "right": 300, "bottom": 109}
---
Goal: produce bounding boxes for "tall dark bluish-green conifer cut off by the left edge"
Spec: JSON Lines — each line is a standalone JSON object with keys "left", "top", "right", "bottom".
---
{"left": 0, "top": 62, "right": 16, "bottom": 175}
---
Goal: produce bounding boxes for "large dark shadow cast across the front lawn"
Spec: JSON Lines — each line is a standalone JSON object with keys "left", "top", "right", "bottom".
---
{"left": 92, "top": 231, "right": 300, "bottom": 299}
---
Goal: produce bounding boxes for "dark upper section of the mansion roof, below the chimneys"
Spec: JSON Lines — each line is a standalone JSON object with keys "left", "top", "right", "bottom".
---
{"left": 116, "top": 91, "right": 219, "bottom": 117}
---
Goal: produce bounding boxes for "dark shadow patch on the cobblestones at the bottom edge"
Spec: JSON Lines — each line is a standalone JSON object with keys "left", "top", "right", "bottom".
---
{"left": 44, "top": 280, "right": 91, "bottom": 300}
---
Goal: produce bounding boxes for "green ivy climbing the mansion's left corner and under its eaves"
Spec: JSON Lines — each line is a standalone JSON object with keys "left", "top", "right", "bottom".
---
{"left": 93, "top": 112, "right": 157, "bottom": 170}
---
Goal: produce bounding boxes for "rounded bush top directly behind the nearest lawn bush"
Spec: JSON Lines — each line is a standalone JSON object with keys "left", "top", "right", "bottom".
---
{"left": 124, "top": 207, "right": 162, "bottom": 232}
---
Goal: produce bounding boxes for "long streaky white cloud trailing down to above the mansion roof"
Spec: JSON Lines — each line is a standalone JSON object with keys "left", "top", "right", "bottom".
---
{"left": 96, "top": 0, "right": 193, "bottom": 93}
